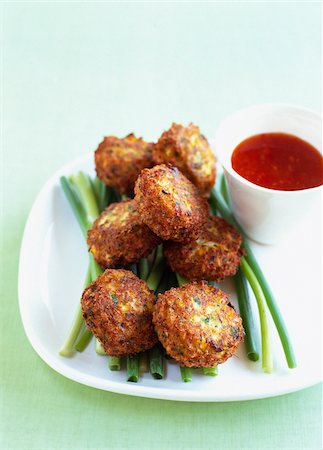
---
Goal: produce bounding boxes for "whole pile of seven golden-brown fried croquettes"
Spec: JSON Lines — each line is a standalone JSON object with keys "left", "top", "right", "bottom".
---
{"left": 81, "top": 123, "right": 244, "bottom": 367}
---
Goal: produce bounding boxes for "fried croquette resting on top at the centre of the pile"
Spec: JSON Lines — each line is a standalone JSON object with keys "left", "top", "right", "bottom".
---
{"left": 135, "top": 164, "right": 208, "bottom": 242}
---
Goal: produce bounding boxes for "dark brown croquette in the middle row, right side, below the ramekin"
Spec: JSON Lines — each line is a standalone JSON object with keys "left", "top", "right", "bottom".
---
{"left": 164, "top": 216, "right": 243, "bottom": 282}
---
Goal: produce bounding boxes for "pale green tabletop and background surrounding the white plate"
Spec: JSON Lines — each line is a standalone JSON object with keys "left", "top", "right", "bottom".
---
{"left": 0, "top": 3, "right": 321, "bottom": 450}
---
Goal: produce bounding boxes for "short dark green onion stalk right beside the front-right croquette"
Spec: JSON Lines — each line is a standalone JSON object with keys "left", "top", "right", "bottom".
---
{"left": 234, "top": 269, "right": 259, "bottom": 361}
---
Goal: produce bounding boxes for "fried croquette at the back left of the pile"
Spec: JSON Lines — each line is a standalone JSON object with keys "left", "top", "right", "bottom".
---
{"left": 94, "top": 134, "right": 154, "bottom": 194}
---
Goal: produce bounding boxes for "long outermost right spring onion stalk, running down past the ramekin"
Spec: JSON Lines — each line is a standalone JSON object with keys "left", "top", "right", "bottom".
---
{"left": 210, "top": 184, "right": 297, "bottom": 369}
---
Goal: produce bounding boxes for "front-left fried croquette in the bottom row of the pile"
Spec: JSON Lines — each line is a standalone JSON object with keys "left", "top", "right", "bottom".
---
{"left": 81, "top": 269, "right": 157, "bottom": 356}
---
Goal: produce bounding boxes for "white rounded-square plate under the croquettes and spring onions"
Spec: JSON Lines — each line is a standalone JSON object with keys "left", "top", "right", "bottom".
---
{"left": 19, "top": 154, "right": 321, "bottom": 402}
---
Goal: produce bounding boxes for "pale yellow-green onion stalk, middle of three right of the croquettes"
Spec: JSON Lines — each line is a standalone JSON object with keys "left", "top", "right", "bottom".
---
{"left": 241, "top": 257, "right": 273, "bottom": 373}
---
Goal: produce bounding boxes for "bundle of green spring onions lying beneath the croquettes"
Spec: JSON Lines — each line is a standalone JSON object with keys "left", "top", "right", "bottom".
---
{"left": 60, "top": 172, "right": 296, "bottom": 382}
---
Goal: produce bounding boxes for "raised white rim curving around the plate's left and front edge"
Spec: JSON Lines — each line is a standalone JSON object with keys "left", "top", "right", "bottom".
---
{"left": 18, "top": 152, "right": 321, "bottom": 402}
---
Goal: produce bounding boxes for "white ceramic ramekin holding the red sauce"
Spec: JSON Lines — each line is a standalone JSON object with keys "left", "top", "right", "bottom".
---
{"left": 212, "top": 103, "right": 322, "bottom": 244}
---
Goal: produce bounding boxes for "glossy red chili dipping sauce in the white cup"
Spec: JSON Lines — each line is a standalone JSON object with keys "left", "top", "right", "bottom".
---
{"left": 231, "top": 133, "right": 323, "bottom": 191}
